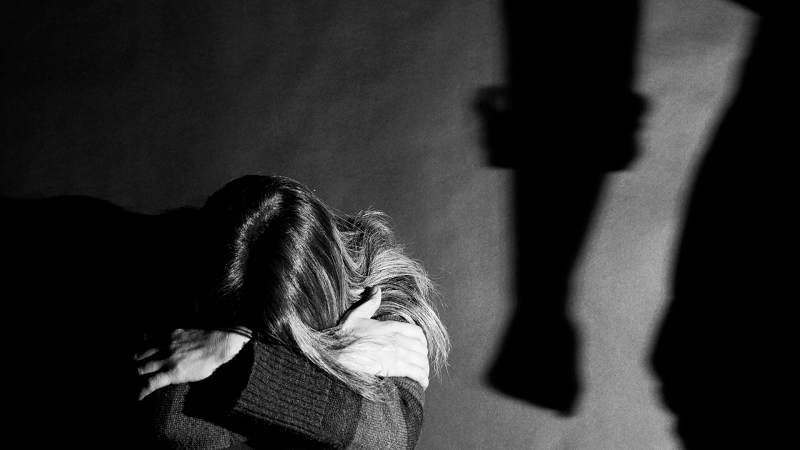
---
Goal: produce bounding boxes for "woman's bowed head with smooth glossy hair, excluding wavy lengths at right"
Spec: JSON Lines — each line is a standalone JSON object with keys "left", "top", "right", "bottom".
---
{"left": 203, "top": 175, "right": 347, "bottom": 340}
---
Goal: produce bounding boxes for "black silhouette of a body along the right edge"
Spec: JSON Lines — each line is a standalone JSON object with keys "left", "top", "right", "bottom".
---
{"left": 652, "top": 2, "right": 798, "bottom": 449}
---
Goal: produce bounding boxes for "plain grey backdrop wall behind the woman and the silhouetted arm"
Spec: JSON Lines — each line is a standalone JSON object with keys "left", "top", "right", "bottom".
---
{"left": 0, "top": 0, "right": 755, "bottom": 450}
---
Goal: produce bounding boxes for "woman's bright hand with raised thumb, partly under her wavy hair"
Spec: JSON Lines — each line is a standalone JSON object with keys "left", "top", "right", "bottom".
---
{"left": 339, "top": 288, "right": 429, "bottom": 389}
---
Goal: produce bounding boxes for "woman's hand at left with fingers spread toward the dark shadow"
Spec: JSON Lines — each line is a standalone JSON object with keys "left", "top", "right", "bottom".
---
{"left": 135, "top": 329, "right": 250, "bottom": 400}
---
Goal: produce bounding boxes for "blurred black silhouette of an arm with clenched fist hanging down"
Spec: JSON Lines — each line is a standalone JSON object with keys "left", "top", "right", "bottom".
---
{"left": 479, "top": 0, "right": 644, "bottom": 414}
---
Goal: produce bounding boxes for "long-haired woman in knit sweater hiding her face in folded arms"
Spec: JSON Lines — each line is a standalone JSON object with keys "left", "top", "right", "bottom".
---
{"left": 137, "top": 175, "right": 449, "bottom": 448}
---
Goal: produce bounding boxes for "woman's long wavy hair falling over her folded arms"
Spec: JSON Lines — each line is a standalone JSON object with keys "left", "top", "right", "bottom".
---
{"left": 198, "top": 175, "right": 450, "bottom": 400}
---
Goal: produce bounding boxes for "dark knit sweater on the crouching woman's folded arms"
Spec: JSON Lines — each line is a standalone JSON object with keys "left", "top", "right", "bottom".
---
{"left": 140, "top": 341, "right": 424, "bottom": 449}
